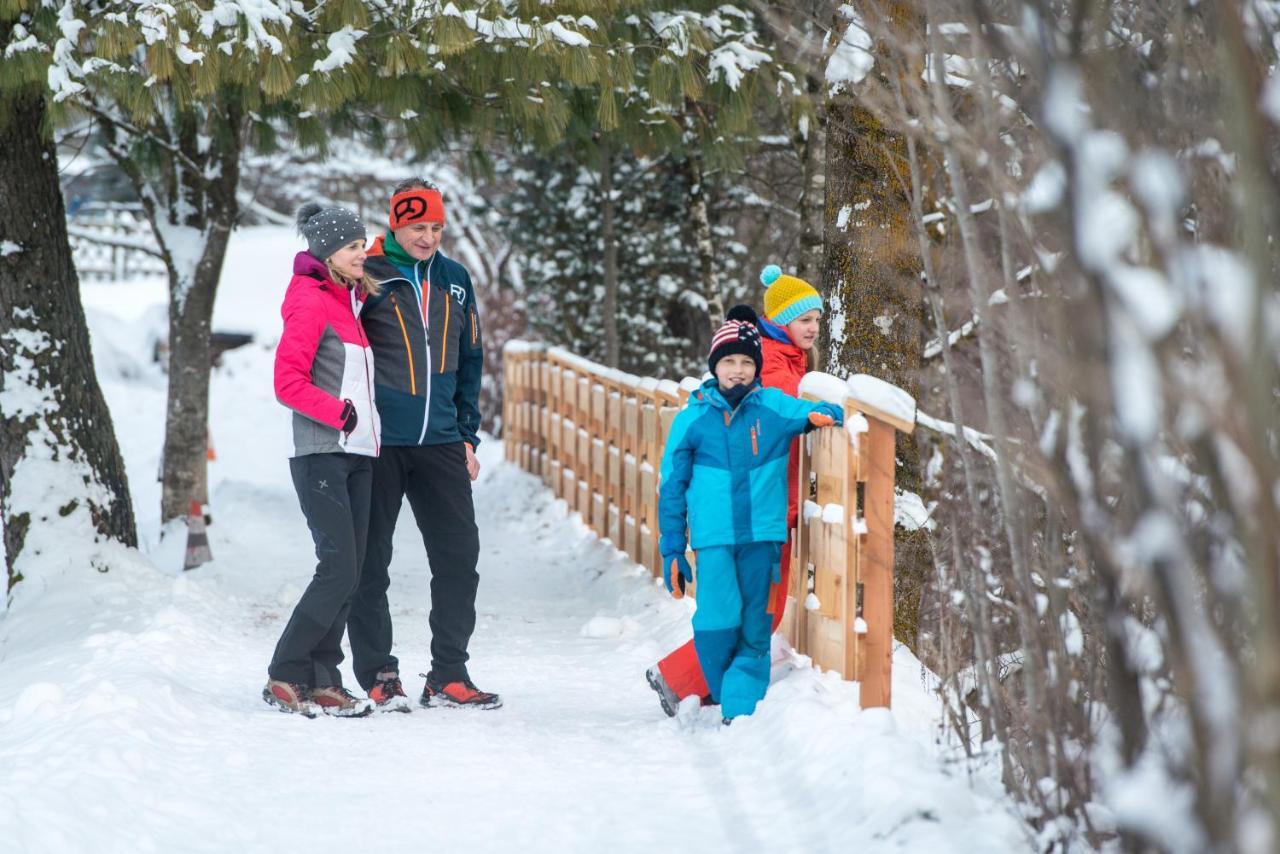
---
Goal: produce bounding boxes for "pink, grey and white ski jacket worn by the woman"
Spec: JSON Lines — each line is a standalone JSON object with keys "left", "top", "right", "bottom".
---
{"left": 275, "top": 252, "right": 381, "bottom": 457}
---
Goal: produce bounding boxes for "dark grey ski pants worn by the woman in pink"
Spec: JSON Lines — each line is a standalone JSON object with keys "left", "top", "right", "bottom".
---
{"left": 266, "top": 453, "right": 372, "bottom": 688}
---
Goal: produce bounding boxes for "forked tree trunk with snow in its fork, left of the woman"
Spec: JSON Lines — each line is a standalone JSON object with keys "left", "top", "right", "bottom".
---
{"left": 156, "top": 102, "right": 242, "bottom": 524}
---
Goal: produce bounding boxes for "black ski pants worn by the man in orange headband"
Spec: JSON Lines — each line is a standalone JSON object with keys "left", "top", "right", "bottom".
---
{"left": 347, "top": 442, "right": 480, "bottom": 691}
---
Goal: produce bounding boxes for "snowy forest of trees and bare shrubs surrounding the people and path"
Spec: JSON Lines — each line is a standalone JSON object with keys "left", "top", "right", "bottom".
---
{"left": 0, "top": 0, "right": 1280, "bottom": 851}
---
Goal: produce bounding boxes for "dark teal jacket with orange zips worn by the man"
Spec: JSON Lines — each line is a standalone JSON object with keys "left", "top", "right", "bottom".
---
{"left": 360, "top": 234, "right": 484, "bottom": 447}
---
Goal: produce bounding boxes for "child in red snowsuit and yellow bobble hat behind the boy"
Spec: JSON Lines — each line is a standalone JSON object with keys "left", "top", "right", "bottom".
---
{"left": 645, "top": 264, "right": 823, "bottom": 714}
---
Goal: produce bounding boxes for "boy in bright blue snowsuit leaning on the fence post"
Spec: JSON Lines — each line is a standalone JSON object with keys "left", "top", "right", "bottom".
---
{"left": 658, "top": 307, "right": 844, "bottom": 722}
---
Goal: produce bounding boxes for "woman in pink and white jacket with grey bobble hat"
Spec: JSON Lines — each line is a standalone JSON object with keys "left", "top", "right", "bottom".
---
{"left": 262, "top": 204, "right": 380, "bottom": 717}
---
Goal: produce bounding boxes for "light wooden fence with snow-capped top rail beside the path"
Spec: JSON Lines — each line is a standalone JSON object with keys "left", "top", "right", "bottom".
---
{"left": 503, "top": 341, "right": 914, "bottom": 708}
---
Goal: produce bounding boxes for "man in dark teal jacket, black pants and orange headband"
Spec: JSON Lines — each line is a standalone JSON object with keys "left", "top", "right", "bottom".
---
{"left": 347, "top": 179, "right": 502, "bottom": 712}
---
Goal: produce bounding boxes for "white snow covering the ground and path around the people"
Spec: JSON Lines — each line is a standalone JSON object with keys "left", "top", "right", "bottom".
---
{"left": 0, "top": 228, "right": 1032, "bottom": 854}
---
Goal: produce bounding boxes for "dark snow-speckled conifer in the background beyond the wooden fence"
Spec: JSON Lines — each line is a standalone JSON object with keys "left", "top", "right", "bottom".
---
{"left": 499, "top": 145, "right": 745, "bottom": 376}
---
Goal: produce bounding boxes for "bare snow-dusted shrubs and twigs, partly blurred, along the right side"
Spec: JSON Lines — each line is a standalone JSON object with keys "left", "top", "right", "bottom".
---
{"left": 844, "top": 0, "right": 1280, "bottom": 851}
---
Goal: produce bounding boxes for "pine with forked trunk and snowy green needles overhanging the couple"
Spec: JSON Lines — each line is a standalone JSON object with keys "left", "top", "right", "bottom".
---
{"left": 0, "top": 0, "right": 619, "bottom": 520}
